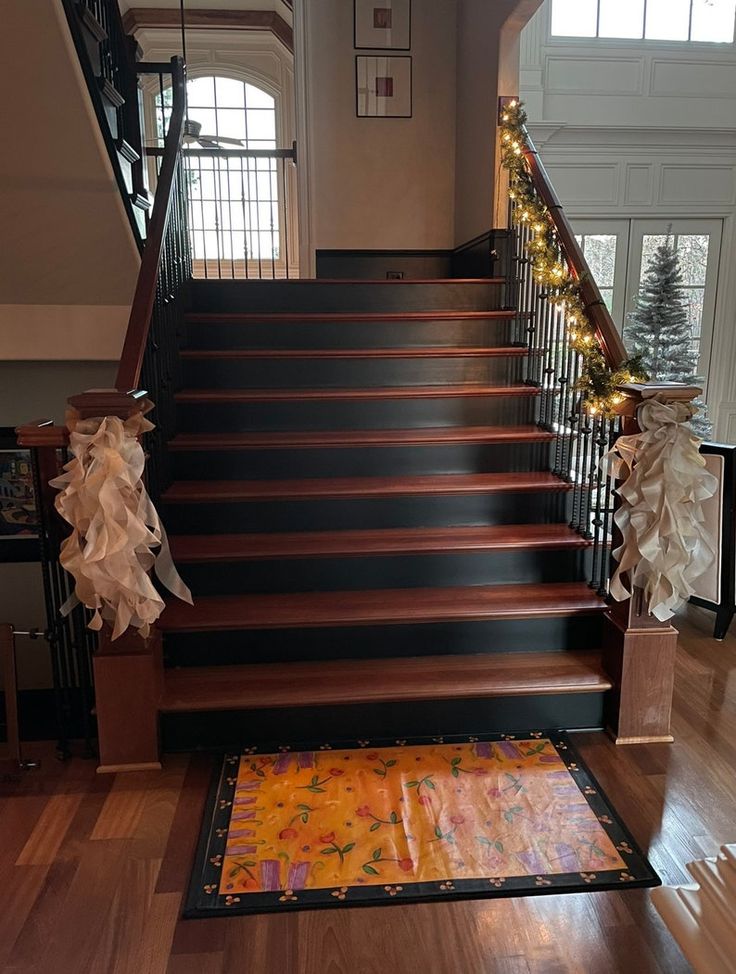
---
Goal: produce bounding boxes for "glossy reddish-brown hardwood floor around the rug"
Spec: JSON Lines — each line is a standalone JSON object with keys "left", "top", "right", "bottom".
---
{"left": 0, "top": 608, "right": 736, "bottom": 974}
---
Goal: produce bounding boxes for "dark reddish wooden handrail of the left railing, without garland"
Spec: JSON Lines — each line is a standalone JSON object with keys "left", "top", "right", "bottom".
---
{"left": 115, "top": 57, "right": 186, "bottom": 392}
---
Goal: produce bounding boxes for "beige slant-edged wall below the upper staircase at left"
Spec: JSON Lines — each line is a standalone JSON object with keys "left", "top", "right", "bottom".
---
{"left": 0, "top": 0, "right": 139, "bottom": 359}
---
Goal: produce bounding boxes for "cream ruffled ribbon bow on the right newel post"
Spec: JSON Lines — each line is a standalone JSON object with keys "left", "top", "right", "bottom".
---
{"left": 601, "top": 397, "right": 718, "bottom": 622}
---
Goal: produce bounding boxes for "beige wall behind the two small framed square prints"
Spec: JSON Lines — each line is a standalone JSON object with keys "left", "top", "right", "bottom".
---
{"left": 297, "top": 0, "right": 456, "bottom": 255}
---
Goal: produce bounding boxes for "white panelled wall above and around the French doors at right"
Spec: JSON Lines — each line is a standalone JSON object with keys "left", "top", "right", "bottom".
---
{"left": 520, "top": 0, "right": 736, "bottom": 442}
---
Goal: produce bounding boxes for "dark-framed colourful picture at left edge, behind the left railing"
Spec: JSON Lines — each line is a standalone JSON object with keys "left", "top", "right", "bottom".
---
{"left": 0, "top": 426, "right": 39, "bottom": 562}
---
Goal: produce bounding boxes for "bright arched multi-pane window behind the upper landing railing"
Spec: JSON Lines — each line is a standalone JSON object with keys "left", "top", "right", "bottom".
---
{"left": 155, "top": 75, "right": 288, "bottom": 277}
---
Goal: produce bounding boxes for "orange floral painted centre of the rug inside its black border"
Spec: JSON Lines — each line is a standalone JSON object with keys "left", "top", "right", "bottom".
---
{"left": 208, "top": 735, "right": 631, "bottom": 904}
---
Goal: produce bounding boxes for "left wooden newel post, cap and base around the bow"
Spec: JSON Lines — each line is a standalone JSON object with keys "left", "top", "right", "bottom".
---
{"left": 69, "top": 389, "right": 163, "bottom": 774}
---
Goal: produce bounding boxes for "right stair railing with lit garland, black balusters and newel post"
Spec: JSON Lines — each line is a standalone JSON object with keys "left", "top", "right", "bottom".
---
{"left": 499, "top": 97, "right": 701, "bottom": 743}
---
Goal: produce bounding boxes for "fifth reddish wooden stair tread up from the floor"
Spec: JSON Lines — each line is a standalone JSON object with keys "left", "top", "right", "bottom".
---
{"left": 168, "top": 425, "right": 555, "bottom": 450}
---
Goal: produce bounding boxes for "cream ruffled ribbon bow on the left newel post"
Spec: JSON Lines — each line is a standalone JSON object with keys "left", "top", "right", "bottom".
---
{"left": 51, "top": 404, "right": 192, "bottom": 639}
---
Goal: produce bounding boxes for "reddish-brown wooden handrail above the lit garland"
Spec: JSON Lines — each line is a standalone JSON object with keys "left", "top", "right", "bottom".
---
{"left": 523, "top": 129, "right": 629, "bottom": 369}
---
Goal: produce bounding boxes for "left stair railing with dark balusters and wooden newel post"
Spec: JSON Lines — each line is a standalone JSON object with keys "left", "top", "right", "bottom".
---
{"left": 18, "top": 57, "right": 191, "bottom": 769}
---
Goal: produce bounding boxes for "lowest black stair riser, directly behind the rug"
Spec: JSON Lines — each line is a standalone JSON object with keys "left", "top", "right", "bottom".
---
{"left": 161, "top": 693, "right": 606, "bottom": 751}
